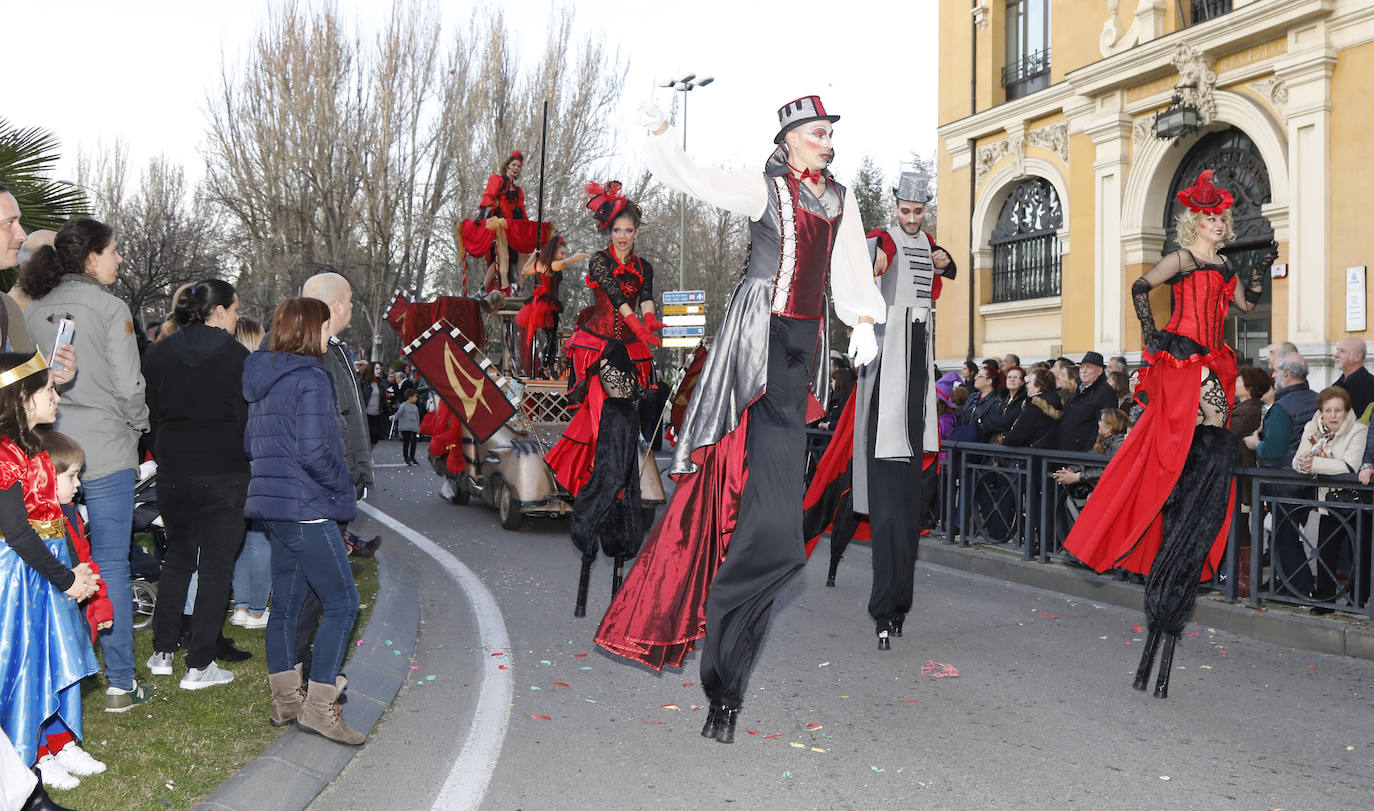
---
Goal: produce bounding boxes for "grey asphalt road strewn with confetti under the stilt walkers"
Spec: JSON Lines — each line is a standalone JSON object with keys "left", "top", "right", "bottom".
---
{"left": 312, "top": 453, "right": 1374, "bottom": 810}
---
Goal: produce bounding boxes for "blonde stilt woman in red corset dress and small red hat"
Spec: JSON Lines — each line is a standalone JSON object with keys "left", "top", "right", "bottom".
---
{"left": 1063, "top": 169, "right": 1278, "bottom": 698}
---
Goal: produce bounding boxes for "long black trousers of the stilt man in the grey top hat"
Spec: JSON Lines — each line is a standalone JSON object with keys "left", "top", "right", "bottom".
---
{"left": 866, "top": 322, "right": 930, "bottom": 623}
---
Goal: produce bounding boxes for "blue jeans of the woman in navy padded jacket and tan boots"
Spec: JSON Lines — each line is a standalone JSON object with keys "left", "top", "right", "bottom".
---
{"left": 264, "top": 521, "right": 357, "bottom": 685}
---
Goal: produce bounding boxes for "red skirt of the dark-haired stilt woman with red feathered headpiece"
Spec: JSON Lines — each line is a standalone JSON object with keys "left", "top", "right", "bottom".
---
{"left": 544, "top": 330, "right": 654, "bottom": 496}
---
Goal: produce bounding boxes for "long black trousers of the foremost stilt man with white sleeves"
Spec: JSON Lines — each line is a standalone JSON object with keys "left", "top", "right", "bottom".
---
{"left": 701, "top": 315, "right": 820, "bottom": 707}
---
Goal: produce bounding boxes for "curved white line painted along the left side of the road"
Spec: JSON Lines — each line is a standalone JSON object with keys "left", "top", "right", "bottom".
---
{"left": 359, "top": 502, "right": 515, "bottom": 811}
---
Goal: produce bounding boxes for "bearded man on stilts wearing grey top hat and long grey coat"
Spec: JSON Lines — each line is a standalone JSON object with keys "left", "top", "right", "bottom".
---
{"left": 804, "top": 172, "right": 958, "bottom": 650}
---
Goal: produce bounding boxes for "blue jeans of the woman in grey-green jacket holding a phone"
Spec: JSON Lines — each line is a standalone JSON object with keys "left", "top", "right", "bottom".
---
{"left": 81, "top": 467, "right": 135, "bottom": 690}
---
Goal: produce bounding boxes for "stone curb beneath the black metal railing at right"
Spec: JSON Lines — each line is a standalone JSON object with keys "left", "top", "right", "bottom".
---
{"left": 921, "top": 535, "right": 1374, "bottom": 660}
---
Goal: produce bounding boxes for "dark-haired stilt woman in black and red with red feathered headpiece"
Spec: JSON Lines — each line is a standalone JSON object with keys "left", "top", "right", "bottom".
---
{"left": 545, "top": 181, "right": 662, "bottom": 617}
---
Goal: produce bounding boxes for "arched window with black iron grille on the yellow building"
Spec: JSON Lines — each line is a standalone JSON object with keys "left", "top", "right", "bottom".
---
{"left": 988, "top": 177, "right": 1063, "bottom": 304}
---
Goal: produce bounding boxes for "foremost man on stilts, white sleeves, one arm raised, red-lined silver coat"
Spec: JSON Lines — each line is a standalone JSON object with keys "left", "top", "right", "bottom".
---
{"left": 596, "top": 96, "right": 886, "bottom": 744}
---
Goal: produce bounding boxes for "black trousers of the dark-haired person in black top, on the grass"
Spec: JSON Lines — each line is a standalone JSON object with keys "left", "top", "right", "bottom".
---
{"left": 153, "top": 473, "right": 249, "bottom": 668}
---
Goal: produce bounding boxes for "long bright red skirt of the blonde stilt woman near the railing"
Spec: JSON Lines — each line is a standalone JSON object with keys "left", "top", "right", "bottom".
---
{"left": 1063, "top": 345, "right": 1235, "bottom": 580}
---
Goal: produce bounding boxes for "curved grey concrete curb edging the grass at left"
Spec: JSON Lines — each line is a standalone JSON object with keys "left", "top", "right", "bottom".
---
{"left": 195, "top": 533, "right": 420, "bottom": 811}
